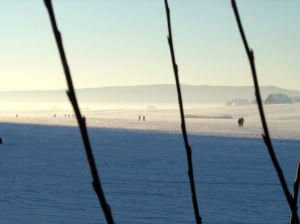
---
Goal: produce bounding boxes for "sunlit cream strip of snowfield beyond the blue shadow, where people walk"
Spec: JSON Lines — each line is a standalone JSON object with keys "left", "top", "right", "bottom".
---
{"left": 0, "top": 103, "right": 300, "bottom": 140}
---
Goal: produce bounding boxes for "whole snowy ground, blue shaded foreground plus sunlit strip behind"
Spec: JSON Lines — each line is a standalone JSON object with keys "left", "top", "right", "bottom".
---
{"left": 0, "top": 104, "right": 300, "bottom": 223}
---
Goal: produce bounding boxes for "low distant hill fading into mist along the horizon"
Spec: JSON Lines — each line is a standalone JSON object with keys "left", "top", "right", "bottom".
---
{"left": 0, "top": 84, "right": 300, "bottom": 105}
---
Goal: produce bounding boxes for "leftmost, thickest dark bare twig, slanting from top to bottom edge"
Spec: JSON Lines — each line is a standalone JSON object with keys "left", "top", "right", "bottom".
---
{"left": 44, "top": 0, "right": 114, "bottom": 223}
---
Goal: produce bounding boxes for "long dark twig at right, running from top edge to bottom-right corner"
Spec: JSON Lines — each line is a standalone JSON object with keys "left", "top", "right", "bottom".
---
{"left": 231, "top": 0, "right": 299, "bottom": 223}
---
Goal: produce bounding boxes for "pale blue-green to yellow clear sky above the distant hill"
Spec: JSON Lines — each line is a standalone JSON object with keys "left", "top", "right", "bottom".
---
{"left": 0, "top": 0, "right": 300, "bottom": 91}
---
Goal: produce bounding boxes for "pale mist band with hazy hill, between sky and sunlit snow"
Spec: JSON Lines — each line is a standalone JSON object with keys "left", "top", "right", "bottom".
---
{"left": 0, "top": 84, "right": 300, "bottom": 111}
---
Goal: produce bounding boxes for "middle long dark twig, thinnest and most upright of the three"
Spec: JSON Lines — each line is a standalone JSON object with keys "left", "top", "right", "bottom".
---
{"left": 165, "top": 0, "right": 202, "bottom": 224}
